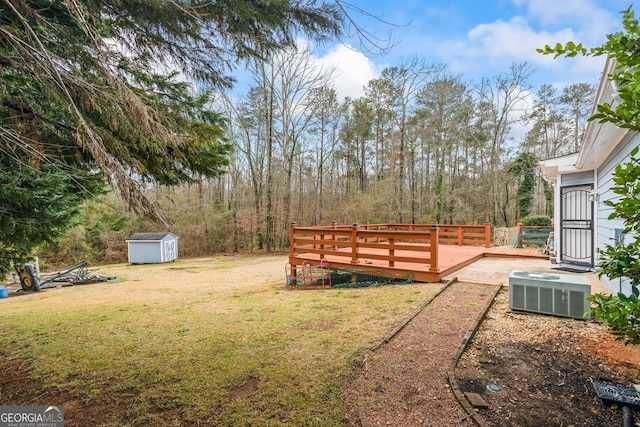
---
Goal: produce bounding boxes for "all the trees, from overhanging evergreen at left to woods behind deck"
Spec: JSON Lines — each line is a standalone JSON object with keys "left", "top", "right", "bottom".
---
{"left": 0, "top": 0, "right": 594, "bottom": 272}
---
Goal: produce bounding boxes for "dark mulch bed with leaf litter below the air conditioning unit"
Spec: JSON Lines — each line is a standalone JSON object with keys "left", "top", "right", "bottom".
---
{"left": 455, "top": 288, "right": 640, "bottom": 427}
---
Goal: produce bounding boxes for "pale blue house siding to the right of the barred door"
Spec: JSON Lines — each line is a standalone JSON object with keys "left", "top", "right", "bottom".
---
{"left": 596, "top": 133, "right": 640, "bottom": 294}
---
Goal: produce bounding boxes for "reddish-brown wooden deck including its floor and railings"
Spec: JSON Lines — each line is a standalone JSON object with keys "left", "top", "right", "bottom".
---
{"left": 289, "top": 224, "right": 548, "bottom": 282}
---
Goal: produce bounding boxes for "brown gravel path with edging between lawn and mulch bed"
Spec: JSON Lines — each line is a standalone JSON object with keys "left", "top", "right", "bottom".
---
{"left": 347, "top": 282, "right": 497, "bottom": 427}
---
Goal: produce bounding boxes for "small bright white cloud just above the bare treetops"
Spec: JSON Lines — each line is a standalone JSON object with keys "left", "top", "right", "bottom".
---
{"left": 318, "top": 44, "right": 380, "bottom": 98}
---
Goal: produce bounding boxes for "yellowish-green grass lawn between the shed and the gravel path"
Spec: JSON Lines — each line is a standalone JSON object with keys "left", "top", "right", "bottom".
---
{"left": 0, "top": 257, "right": 441, "bottom": 426}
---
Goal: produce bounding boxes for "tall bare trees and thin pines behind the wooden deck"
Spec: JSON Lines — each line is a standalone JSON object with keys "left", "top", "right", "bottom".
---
{"left": 40, "top": 54, "right": 595, "bottom": 268}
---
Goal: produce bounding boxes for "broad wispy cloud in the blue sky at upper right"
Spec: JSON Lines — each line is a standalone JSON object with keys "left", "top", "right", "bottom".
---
{"left": 438, "top": 0, "right": 619, "bottom": 86}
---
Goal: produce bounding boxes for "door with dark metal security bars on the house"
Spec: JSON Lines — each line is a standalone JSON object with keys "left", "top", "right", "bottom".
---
{"left": 560, "top": 184, "right": 593, "bottom": 267}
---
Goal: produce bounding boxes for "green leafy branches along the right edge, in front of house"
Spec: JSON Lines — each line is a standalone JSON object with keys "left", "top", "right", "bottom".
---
{"left": 538, "top": 6, "right": 640, "bottom": 344}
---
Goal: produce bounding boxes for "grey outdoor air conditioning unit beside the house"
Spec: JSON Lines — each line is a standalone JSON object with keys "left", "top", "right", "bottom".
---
{"left": 509, "top": 270, "right": 591, "bottom": 319}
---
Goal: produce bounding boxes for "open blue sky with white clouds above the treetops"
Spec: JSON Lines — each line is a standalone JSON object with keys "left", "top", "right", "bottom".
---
{"left": 314, "top": 0, "right": 639, "bottom": 98}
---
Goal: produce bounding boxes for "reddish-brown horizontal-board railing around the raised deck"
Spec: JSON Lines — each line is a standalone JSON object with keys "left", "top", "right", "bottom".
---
{"left": 290, "top": 223, "right": 491, "bottom": 272}
